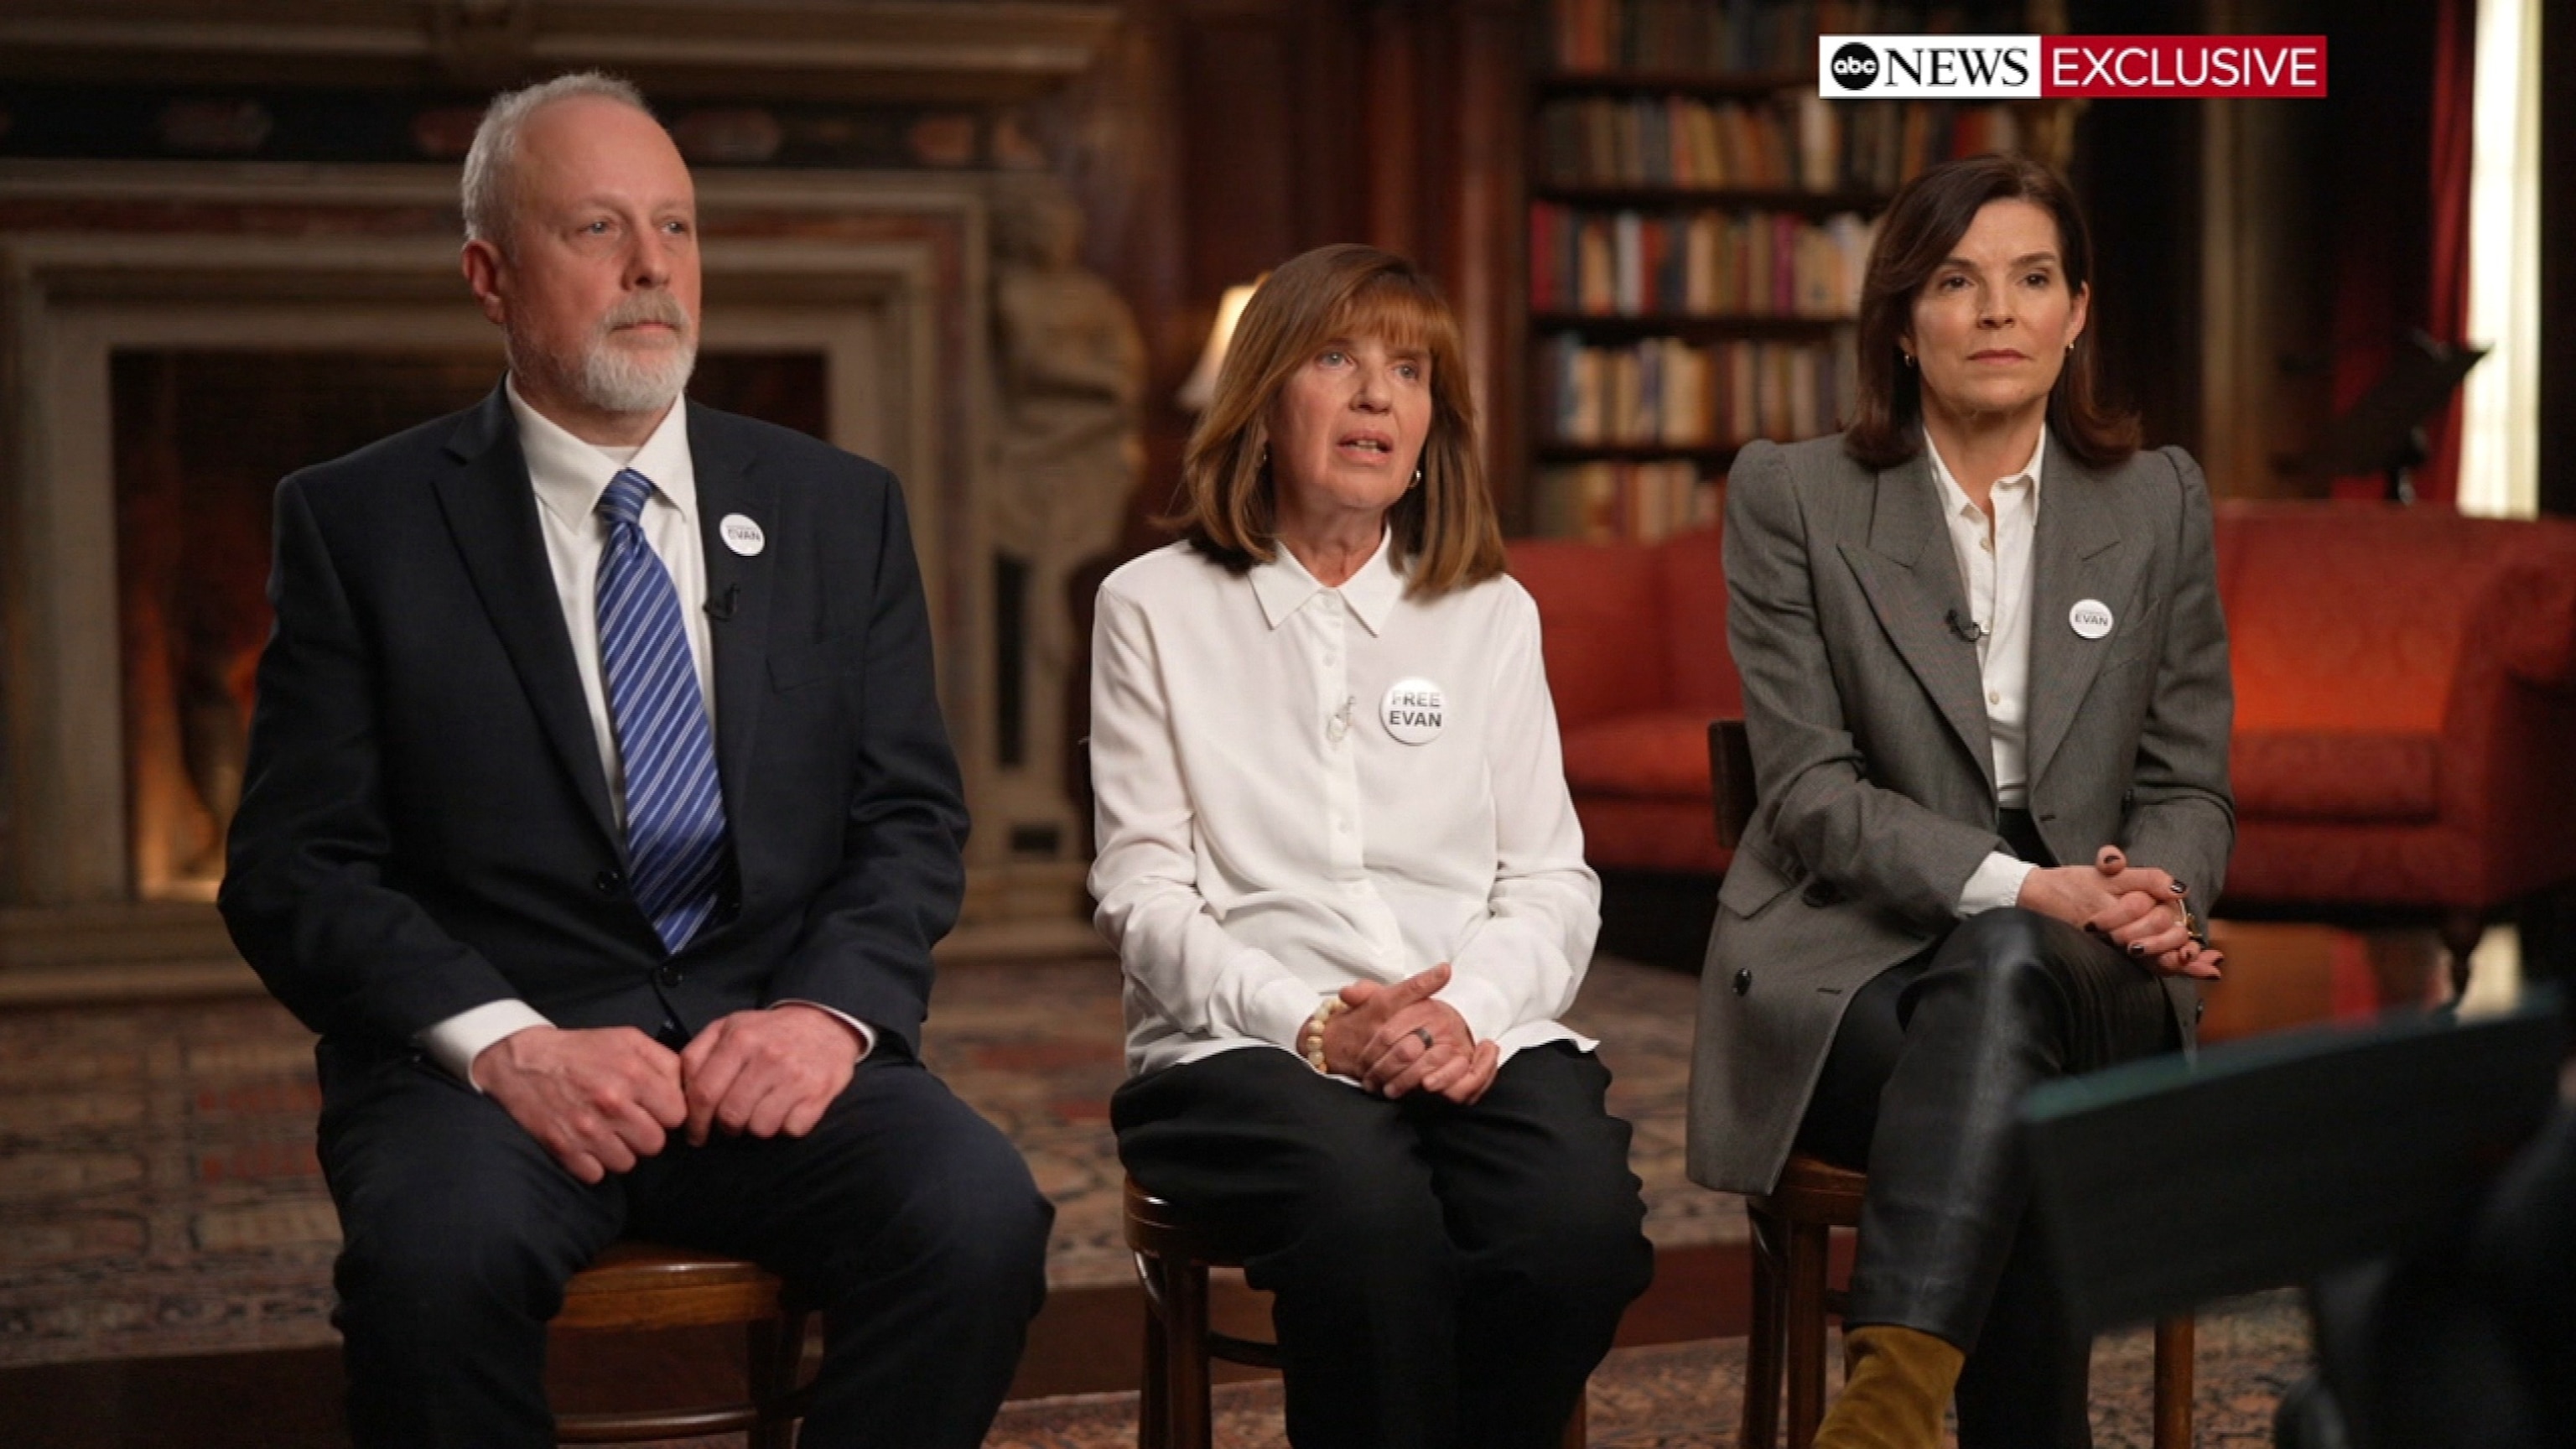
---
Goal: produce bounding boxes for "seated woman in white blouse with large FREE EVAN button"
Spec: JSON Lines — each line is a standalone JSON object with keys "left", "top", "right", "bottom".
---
{"left": 1093, "top": 245, "right": 1654, "bottom": 1449}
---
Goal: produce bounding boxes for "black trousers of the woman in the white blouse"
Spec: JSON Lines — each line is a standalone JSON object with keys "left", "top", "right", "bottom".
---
{"left": 1110, "top": 1044, "right": 1654, "bottom": 1449}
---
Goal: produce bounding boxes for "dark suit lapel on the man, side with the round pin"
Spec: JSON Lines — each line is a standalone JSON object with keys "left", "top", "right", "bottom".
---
{"left": 688, "top": 405, "right": 786, "bottom": 840}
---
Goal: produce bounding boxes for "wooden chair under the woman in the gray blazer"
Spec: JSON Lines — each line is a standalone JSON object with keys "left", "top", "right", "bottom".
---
{"left": 1737, "top": 1152, "right": 2192, "bottom": 1449}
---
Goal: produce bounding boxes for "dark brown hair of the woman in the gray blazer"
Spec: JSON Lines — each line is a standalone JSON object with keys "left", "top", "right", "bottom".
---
{"left": 1841, "top": 154, "right": 2138, "bottom": 467}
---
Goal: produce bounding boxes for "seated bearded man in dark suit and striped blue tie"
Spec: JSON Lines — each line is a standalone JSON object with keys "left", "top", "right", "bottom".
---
{"left": 221, "top": 75, "right": 1051, "bottom": 1449}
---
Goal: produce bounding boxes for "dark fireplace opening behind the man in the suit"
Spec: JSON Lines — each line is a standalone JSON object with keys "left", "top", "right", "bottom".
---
{"left": 108, "top": 348, "right": 829, "bottom": 900}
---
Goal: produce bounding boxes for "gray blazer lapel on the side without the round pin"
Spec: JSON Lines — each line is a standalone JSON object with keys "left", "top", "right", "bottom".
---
{"left": 1841, "top": 456, "right": 1994, "bottom": 789}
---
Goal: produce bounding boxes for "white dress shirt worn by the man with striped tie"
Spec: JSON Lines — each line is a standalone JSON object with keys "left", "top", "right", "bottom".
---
{"left": 420, "top": 379, "right": 875, "bottom": 1088}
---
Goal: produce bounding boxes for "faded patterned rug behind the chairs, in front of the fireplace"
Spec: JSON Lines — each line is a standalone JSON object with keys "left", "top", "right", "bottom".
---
{"left": 0, "top": 959, "right": 1744, "bottom": 1364}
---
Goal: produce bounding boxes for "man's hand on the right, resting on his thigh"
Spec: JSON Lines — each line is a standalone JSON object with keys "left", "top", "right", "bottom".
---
{"left": 680, "top": 1000, "right": 863, "bottom": 1147}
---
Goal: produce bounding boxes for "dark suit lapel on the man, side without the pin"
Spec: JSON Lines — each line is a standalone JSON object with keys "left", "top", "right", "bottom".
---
{"left": 438, "top": 389, "right": 626, "bottom": 859}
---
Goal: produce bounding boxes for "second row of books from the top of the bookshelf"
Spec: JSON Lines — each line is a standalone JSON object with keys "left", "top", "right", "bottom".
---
{"left": 1538, "top": 93, "right": 2023, "bottom": 194}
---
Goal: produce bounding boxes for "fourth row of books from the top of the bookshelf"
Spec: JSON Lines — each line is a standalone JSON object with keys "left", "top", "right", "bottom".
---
{"left": 1535, "top": 327, "right": 1860, "bottom": 449}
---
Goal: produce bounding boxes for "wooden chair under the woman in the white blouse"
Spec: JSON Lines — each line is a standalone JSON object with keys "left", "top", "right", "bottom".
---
{"left": 1125, "top": 1181, "right": 1584, "bottom": 1449}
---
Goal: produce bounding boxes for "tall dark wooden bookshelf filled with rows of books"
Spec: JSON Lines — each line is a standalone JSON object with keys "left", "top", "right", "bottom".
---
{"left": 1519, "top": 0, "right": 2025, "bottom": 542}
